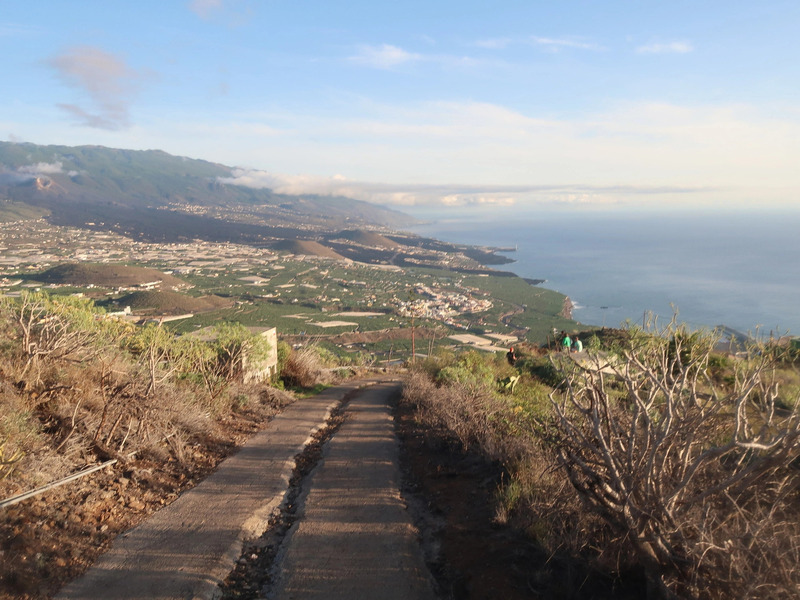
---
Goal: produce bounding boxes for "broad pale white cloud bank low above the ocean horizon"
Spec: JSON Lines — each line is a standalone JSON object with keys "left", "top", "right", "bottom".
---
{"left": 126, "top": 98, "right": 800, "bottom": 211}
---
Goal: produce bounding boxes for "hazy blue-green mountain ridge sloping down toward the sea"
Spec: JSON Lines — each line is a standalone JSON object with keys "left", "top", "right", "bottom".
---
{"left": 0, "top": 142, "right": 414, "bottom": 232}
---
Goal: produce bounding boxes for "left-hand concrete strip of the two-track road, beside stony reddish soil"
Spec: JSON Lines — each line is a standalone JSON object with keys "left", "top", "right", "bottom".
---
{"left": 56, "top": 380, "right": 378, "bottom": 600}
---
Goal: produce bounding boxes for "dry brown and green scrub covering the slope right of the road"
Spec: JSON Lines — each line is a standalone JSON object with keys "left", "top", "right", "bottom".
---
{"left": 404, "top": 323, "right": 800, "bottom": 599}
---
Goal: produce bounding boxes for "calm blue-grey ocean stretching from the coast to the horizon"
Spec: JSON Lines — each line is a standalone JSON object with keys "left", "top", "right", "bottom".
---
{"left": 407, "top": 207, "right": 800, "bottom": 335}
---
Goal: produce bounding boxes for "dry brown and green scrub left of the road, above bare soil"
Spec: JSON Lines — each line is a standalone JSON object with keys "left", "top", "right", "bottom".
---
{"left": 0, "top": 293, "right": 340, "bottom": 497}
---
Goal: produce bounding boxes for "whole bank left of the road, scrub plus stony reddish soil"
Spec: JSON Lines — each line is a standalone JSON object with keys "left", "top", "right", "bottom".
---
{"left": 0, "top": 292, "right": 350, "bottom": 598}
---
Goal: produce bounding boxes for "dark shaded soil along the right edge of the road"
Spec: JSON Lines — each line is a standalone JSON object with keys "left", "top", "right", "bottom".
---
{"left": 395, "top": 396, "right": 644, "bottom": 600}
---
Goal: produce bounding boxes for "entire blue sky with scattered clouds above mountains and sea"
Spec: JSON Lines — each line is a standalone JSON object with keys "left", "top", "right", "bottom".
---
{"left": 0, "top": 0, "right": 800, "bottom": 208}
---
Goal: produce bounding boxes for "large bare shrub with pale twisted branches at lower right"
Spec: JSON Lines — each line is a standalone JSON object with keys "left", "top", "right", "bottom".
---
{"left": 551, "top": 322, "right": 800, "bottom": 598}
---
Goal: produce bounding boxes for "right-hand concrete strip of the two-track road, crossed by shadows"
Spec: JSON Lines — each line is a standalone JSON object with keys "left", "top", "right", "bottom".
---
{"left": 267, "top": 383, "right": 436, "bottom": 600}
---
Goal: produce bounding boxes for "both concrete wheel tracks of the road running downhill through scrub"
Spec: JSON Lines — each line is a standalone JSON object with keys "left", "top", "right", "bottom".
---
{"left": 56, "top": 380, "right": 433, "bottom": 600}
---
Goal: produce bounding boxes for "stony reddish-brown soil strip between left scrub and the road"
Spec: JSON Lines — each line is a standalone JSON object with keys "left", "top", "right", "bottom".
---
{"left": 0, "top": 409, "right": 278, "bottom": 600}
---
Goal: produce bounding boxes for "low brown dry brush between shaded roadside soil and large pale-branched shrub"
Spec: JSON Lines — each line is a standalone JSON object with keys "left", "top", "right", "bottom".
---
{"left": 403, "top": 362, "right": 604, "bottom": 580}
